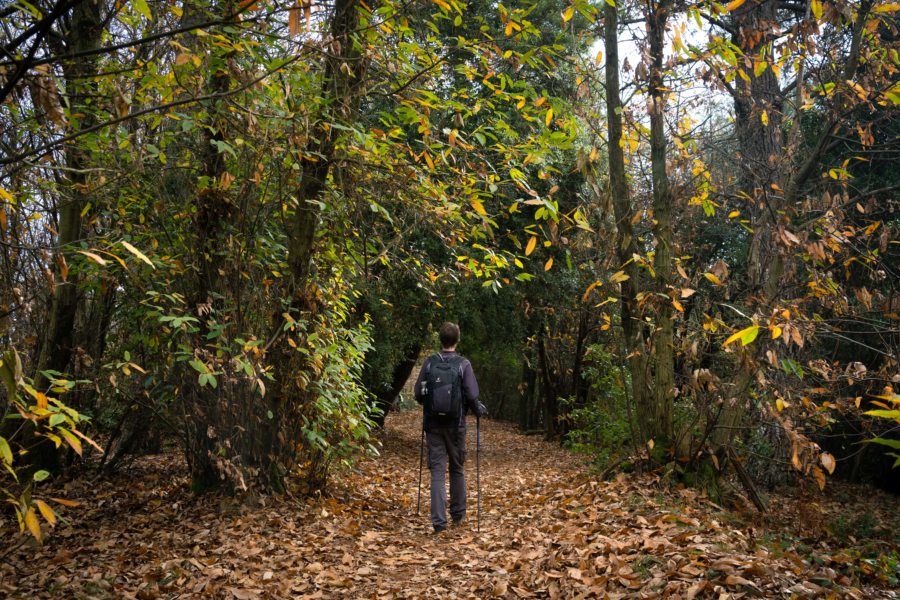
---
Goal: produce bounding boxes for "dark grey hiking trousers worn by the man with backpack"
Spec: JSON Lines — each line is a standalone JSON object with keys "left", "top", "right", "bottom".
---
{"left": 425, "top": 427, "right": 466, "bottom": 530}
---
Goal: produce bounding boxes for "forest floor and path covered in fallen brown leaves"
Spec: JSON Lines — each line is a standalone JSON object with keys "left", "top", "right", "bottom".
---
{"left": 0, "top": 412, "right": 900, "bottom": 600}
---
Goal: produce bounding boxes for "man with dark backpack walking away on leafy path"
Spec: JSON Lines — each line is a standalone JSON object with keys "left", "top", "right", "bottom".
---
{"left": 415, "top": 323, "right": 487, "bottom": 533}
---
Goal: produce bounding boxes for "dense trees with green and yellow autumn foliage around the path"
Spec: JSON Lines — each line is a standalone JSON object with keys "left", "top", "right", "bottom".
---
{"left": 0, "top": 0, "right": 900, "bottom": 548}
